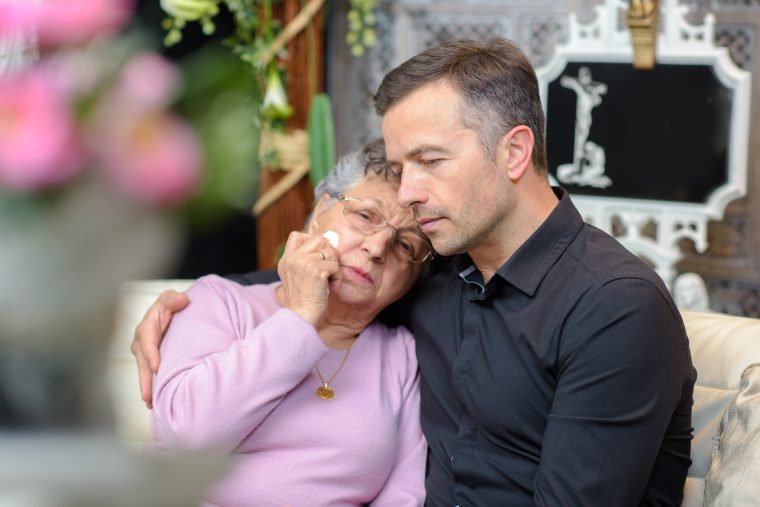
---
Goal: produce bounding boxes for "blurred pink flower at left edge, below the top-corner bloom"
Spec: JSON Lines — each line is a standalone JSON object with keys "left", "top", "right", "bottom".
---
{"left": 0, "top": 68, "right": 85, "bottom": 190}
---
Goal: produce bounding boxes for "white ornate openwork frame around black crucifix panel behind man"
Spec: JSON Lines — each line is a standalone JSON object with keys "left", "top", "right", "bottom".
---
{"left": 537, "top": 0, "right": 751, "bottom": 294}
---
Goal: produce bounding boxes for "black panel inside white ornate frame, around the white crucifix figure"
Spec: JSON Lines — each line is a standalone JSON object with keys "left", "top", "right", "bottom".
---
{"left": 547, "top": 62, "right": 732, "bottom": 202}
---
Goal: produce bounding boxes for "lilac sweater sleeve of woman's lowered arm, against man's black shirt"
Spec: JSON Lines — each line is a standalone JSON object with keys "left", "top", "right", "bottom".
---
{"left": 370, "top": 327, "right": 427, "bottom": 507}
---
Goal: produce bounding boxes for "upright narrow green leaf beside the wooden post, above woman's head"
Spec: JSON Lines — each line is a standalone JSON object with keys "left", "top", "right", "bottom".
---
{"left": 306, "top": 94, "right": 335, "bottom": 186}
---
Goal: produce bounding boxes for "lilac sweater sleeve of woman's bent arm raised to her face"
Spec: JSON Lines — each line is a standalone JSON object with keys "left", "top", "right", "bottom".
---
{"left": 153, "top": 277, "right": 327, "bottom": 452}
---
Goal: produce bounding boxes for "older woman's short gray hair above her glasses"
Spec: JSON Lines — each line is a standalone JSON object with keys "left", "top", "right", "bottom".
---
{"left": 314, "top": 139, "right": 393, "bottom": 202}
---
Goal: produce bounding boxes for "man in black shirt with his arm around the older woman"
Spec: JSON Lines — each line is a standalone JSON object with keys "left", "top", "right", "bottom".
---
{"left": 133, "top": 39, "right": 696, "bottom": 507}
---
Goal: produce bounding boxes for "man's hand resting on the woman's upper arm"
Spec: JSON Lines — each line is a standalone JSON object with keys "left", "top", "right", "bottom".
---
{"left": 129, "top": 290, "right": 189, "bottom": 408}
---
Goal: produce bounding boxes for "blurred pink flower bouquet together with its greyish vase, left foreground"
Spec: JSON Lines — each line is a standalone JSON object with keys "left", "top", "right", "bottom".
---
{"left": 0, "top": 0, "right": 203, "bottom": 432}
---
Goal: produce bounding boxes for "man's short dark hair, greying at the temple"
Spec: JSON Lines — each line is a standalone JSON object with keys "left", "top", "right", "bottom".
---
{"left": 374, "top": 38, "right": 547, "bottom": 174}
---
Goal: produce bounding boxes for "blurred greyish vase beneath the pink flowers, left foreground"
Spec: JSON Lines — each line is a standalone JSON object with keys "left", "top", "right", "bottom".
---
{"left": 0, "top": 179, "right": 180, "bottom": 429}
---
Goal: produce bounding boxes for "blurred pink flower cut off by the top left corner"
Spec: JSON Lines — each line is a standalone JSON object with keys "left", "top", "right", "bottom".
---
{"left": 0, "top": 0, "right": 133, "bottom": 46}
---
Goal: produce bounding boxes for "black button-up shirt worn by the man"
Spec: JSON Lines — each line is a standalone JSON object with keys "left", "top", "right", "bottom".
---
{"left": 396, "top": 190, "right": 696, "bottom": 507}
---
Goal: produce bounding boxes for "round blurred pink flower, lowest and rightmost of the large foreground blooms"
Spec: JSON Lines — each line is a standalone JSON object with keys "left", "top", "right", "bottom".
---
{"left": 99, "top": 111, "right": 202, "bottom": 204}
